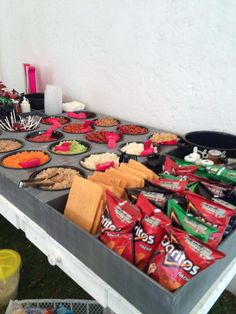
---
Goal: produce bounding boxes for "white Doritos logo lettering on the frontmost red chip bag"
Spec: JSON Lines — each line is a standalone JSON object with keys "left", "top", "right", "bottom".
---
{"left": 161, "top": 235, "right": 200, "bottom": 276}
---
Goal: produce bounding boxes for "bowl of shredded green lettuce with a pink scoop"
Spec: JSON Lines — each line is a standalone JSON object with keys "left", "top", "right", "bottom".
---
{"left": 48, "top": 140, "right": 91, "bottom": 155}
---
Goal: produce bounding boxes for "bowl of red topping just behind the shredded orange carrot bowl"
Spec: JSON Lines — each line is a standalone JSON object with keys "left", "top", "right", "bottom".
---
{"left": 25, "top": 130, "right": 64, "bottom": 143}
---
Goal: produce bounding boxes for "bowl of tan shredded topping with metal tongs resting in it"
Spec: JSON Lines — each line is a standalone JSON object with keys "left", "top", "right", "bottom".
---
{"left": 29, "top": 166, "right": 84, "bottom": 191}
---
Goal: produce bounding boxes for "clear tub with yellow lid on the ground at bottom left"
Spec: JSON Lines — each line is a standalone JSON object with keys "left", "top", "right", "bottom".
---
{"left": 0, "top": 250, "right": 21, "bottom": 306}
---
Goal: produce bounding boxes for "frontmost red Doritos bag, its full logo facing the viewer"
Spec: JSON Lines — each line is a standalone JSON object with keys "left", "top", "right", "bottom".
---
{"left": 147, "top": 227, "right": 225, "bottom": 291}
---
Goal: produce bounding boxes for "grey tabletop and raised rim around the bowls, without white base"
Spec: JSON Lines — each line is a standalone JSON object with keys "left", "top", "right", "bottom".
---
{"left": 0, "top": 109, "right": 236, "bottom": 314}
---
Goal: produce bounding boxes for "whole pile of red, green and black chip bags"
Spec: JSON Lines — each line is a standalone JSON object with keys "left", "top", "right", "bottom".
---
{"left": 100, "top": 156, "right": 236, "bottom": 291}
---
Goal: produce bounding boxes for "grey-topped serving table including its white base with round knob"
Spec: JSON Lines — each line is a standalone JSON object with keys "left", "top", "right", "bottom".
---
{"left": 0, "top": 111, "right": 236, "bottom": 314}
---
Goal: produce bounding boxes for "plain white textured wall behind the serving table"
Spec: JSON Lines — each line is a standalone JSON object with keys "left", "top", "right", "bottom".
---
{"left": 0, "top": 0, "right": 236, "bottom": 133}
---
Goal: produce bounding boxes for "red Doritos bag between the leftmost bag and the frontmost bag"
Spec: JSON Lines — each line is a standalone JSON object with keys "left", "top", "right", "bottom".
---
{"left": 134, "top": 194, "right": 171, "bottom": 270}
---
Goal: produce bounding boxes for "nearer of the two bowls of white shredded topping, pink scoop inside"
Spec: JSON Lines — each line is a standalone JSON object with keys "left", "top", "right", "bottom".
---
{"left": 79, "top": 152, "right": 119, "bottom": 171}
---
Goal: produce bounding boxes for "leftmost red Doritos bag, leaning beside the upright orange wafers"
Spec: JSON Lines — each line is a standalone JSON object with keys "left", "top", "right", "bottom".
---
{"left": 100, "top": 191, "right": 142, "bottom": 263}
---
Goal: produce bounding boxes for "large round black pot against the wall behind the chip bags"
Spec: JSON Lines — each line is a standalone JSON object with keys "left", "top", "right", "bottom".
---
{"left": 178, "top": 131, "right": 236, "bottom": 158}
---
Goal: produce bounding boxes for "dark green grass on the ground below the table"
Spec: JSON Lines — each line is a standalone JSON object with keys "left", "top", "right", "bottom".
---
{"left": 0, "top": 216, "right": 236, "bottom": 314}
